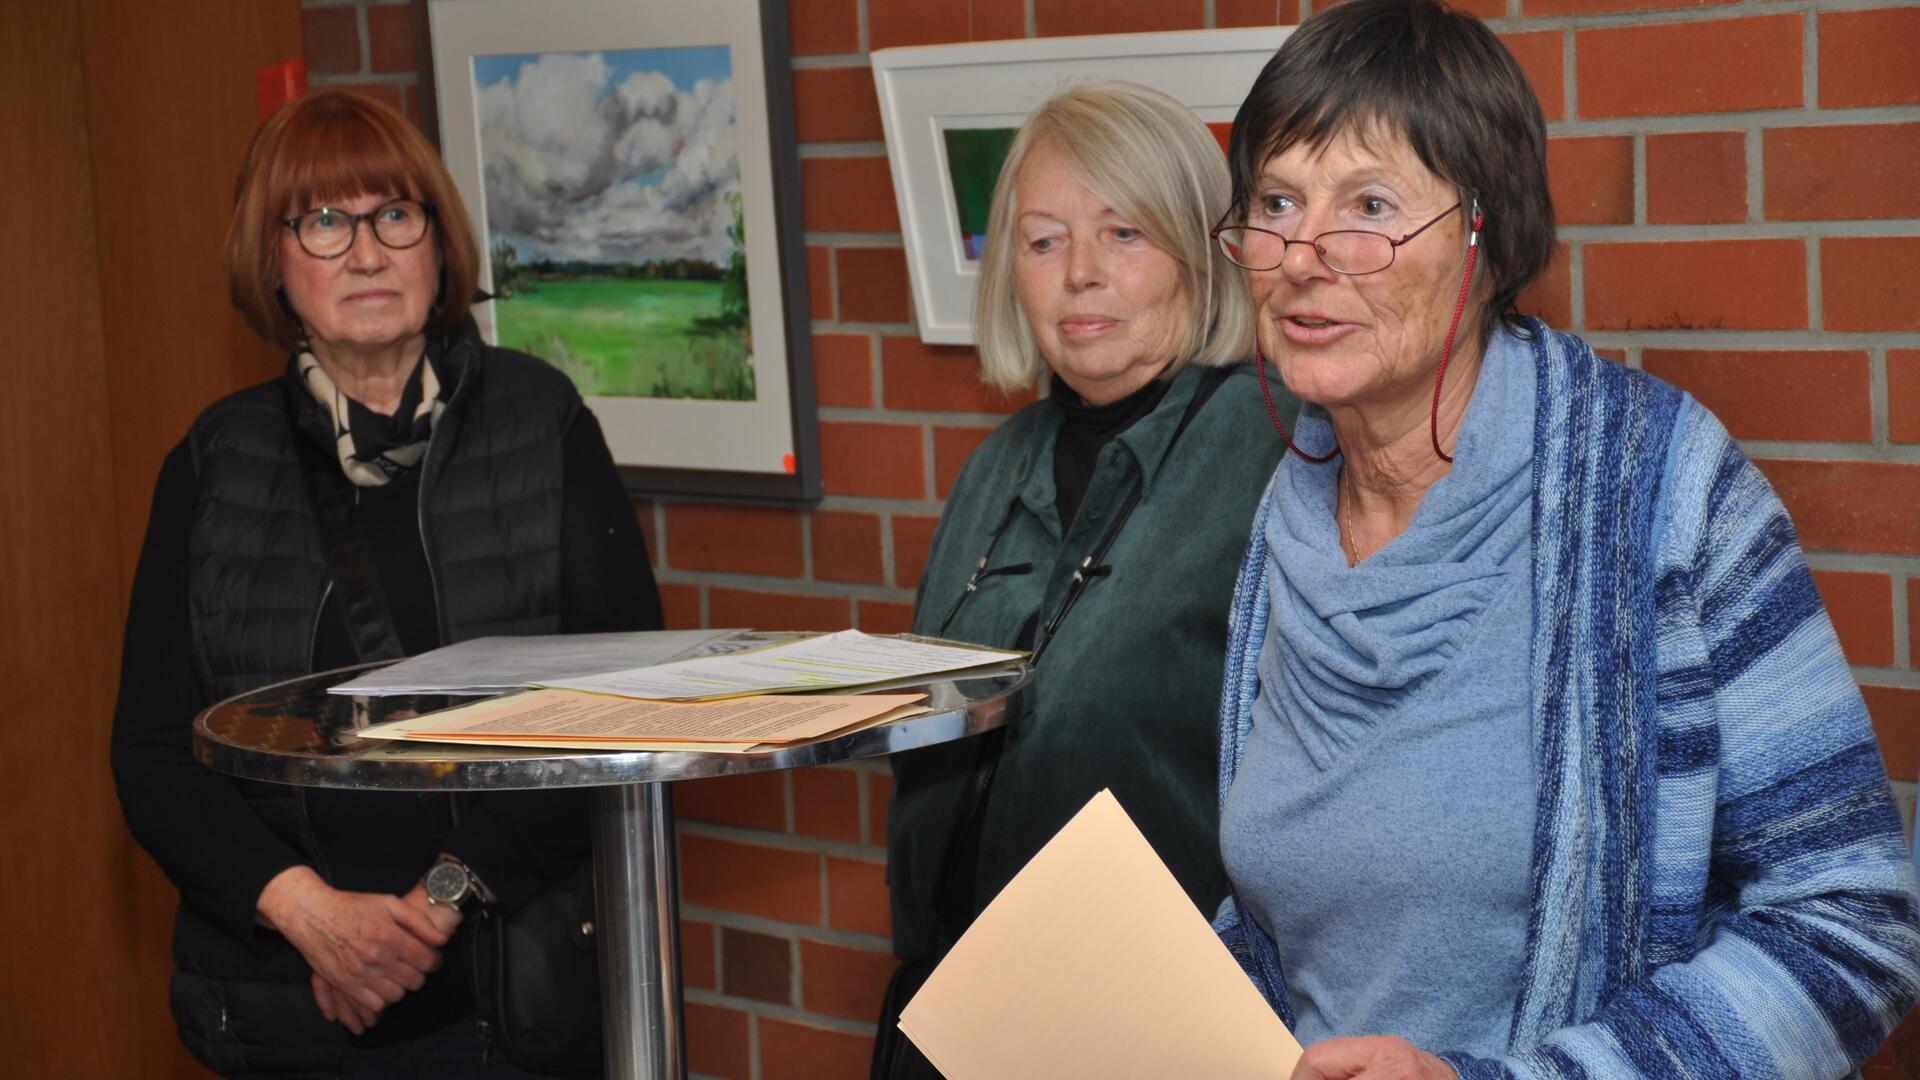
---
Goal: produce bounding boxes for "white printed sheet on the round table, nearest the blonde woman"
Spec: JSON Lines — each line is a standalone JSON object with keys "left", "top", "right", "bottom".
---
{"left": 536, "top": 630, "right": 1025, "bottom": 701}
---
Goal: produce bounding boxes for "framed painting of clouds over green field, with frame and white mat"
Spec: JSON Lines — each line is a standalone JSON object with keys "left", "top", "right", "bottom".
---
{"left": 428, "top": 0, "right": 820, "bottom": 502}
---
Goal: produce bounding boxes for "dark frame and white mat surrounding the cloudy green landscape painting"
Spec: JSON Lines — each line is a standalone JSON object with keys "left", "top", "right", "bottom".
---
{"left": 428, "top": 0, "right": 820, "bottom": 502}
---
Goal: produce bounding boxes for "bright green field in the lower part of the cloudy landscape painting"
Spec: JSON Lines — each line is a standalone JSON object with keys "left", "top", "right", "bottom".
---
{"left": 493, "top": 277, "right": 755, "bottom": 402}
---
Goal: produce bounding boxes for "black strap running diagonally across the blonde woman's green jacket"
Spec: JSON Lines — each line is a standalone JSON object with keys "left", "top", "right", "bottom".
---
{"left": 933, "top": 367, "right": 1233, "bottom": 955}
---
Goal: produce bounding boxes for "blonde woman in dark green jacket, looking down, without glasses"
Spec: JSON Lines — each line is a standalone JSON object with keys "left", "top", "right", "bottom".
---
{"left": 874, "top": 83, "right": 1294, "bottom": 1076}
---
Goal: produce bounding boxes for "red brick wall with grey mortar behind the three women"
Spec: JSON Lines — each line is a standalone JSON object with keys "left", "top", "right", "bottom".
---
{"left": 307, "top": 0, "right": 1920, "bottom": 1080}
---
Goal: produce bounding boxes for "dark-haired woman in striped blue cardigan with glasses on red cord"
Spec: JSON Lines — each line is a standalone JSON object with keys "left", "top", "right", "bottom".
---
{"left": 1215, "top": 0, "right": 1920, "bottom": 1080}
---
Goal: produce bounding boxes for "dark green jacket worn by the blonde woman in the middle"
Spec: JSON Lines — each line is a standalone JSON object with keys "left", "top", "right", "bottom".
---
{"left": 887, "top": 365, "right": 1298, "bottom": 961}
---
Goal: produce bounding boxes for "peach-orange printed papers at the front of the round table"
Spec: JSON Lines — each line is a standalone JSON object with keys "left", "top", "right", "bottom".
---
{"left": 355, "top": 690, "right": 927, "bottom": 753}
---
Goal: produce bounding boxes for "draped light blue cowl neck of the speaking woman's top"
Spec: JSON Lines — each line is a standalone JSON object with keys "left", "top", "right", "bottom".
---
{"left": 1261, "top": 327, "right": 1534, "bottom": 769}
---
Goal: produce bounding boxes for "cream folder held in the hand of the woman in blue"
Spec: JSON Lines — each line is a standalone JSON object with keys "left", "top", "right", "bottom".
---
{"left": 900, "top": 780, "right": 1300, "bottom": 1080}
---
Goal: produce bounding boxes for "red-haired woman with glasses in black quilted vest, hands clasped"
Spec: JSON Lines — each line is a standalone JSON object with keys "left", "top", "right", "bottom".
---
{"left": 113, "top": 92, "right": 660, "bottom": 1076}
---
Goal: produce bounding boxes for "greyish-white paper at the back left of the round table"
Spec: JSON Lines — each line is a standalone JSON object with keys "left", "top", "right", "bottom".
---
{"left": 328, "top": 630, "right": 739, "bottom": 698}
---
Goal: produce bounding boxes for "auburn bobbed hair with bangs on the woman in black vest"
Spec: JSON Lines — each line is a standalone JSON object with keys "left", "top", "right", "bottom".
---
{"left": 227, "top": 90, "right": 480, "bottom": 350}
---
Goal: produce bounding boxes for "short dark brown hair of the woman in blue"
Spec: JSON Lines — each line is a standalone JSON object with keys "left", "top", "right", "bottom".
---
{"left": 1227, "top": 0, "right": 1553, "bottom": 334}
